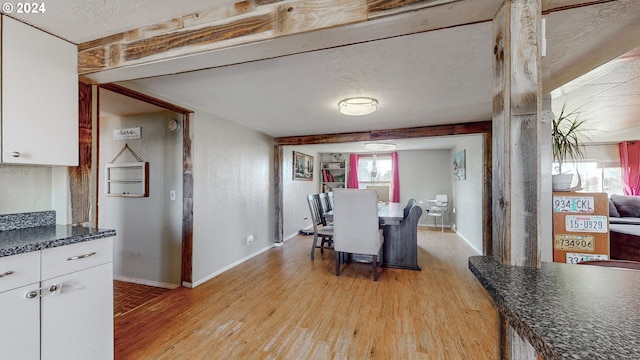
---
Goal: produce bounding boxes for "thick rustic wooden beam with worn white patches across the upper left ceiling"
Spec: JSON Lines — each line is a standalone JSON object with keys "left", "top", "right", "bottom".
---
{"left": 78, "top": 0, "right": 461, "bottom": 75}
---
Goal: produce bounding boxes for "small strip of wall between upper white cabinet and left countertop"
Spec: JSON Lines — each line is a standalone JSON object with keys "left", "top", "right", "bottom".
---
{"left": 0, "top": 164, "right": 52, "bottom": 214}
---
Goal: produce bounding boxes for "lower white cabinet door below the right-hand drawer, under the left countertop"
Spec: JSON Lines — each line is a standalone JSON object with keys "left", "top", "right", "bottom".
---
{"left": 41, "top": 263, "right": 113, "bottom": 360}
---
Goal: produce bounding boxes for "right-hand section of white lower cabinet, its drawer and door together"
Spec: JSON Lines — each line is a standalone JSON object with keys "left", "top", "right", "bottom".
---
{"left": 40, "top": 238, "right": 113, "bottom": 360}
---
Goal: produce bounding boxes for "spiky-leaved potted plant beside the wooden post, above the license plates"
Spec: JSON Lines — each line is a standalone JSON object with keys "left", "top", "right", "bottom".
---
{"left": 551, "top": 102, "right": 589, "bottom": 174}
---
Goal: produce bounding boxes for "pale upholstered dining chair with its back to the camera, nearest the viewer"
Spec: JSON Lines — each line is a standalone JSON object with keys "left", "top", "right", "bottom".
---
{"left": 333, "top": 189, "right": 384, "bottom": 281}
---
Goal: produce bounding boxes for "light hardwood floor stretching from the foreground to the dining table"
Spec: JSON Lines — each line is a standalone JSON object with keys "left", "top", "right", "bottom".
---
{"left": 115, "top": 228, "right": 499, "bottom": 360}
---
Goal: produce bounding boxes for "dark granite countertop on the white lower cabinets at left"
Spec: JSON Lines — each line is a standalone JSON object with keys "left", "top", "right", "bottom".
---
{"left": 0, "top": 225, "right": 116, "bottom": 257}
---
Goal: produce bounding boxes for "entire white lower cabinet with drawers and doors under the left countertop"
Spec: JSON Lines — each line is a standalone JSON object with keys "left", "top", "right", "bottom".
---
{"left": 0, "top": 238, "right": 113, "bottom": 360}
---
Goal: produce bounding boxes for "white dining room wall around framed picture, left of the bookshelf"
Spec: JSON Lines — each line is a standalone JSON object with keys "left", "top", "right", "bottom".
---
{"left": 282, "top": 146, "right": 321, "bottom": 240}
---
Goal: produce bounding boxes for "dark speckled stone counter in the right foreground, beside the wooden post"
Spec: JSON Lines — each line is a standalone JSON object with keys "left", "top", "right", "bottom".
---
{"left": 469, "top": 256, "right": 640, "bottom": 360}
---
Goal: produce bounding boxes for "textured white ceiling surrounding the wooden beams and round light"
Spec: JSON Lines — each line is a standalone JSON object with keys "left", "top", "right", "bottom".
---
{"left": 6, "top": 0, "right": 640, "bottom": 149}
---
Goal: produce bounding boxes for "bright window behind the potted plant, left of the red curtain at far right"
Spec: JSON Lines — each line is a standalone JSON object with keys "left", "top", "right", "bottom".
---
{"left": 554, "top": 162, "right": 624, "bottom": 195}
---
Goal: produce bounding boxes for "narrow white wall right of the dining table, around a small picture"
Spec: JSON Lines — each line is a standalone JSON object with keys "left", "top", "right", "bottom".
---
{"left": 449, "top": 135, "right": 482, "bottom": 254}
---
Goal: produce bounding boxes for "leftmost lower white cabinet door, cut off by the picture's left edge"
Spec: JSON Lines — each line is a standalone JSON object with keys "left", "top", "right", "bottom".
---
{"left": 0, "top": 283, "right": 40, "bottom": 360}
